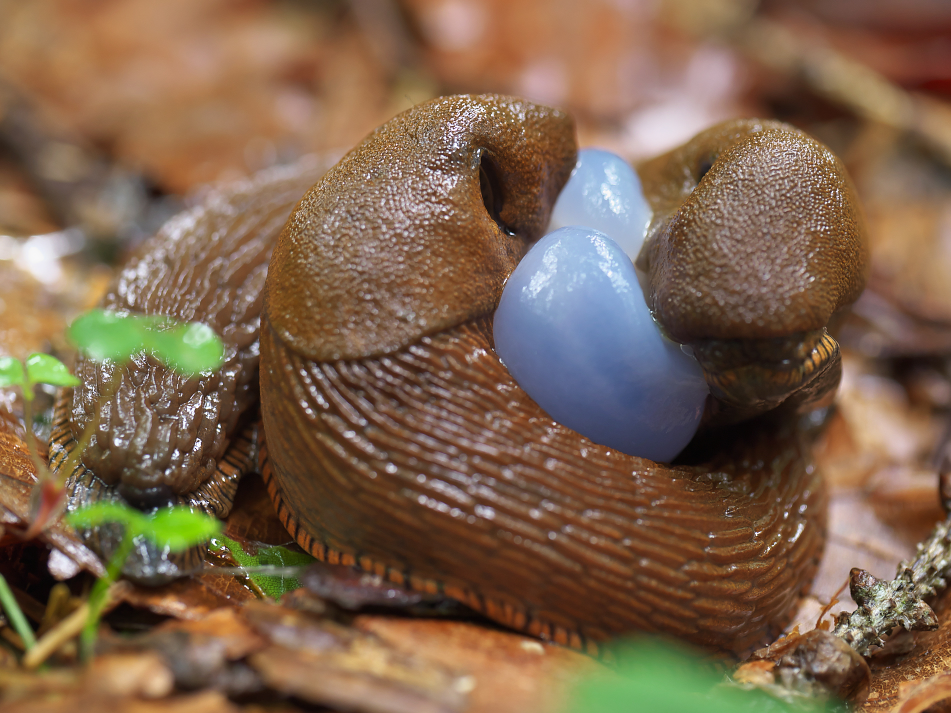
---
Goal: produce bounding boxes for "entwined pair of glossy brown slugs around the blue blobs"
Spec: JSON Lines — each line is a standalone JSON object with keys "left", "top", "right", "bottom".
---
{"left": 53, "top": 96, "right": 867, "bottom": 649}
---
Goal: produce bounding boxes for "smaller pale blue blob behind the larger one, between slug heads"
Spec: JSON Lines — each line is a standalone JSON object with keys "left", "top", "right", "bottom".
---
{"left": 548, "top": 149, "right": 651, "bottom": 260}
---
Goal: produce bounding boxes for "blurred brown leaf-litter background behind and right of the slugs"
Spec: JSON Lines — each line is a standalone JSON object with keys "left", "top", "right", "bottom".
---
{"left": 0, "top": 0, "right": 951, "bottom": 656}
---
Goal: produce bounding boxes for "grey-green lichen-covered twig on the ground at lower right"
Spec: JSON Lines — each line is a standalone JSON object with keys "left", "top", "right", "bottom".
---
{"left": 833, "top": 518, "right": 951, "bottom": 656}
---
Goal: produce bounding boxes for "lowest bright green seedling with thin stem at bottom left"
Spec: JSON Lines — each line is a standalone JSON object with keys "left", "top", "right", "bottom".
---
{"left": 66, "top": 502, "right": 221, "bottom": 657}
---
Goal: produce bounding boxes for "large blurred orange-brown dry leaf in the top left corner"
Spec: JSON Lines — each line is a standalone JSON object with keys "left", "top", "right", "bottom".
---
{"left": 0, "top": 0, "right": 406, "bottom": 193}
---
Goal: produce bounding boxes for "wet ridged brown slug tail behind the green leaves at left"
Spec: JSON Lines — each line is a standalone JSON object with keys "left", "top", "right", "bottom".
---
{"left": 70, "top": 167, "right": 322, "bottom": 505}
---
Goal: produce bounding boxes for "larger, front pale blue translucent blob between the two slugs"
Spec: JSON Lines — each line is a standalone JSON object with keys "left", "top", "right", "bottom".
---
{"left": 494, "top": 227, "right": 708, "bottom": 461}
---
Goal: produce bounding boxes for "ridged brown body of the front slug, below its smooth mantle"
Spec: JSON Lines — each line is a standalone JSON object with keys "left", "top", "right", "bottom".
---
{"left": 261, "top": 319, "right": 825, "bottom": 651}
